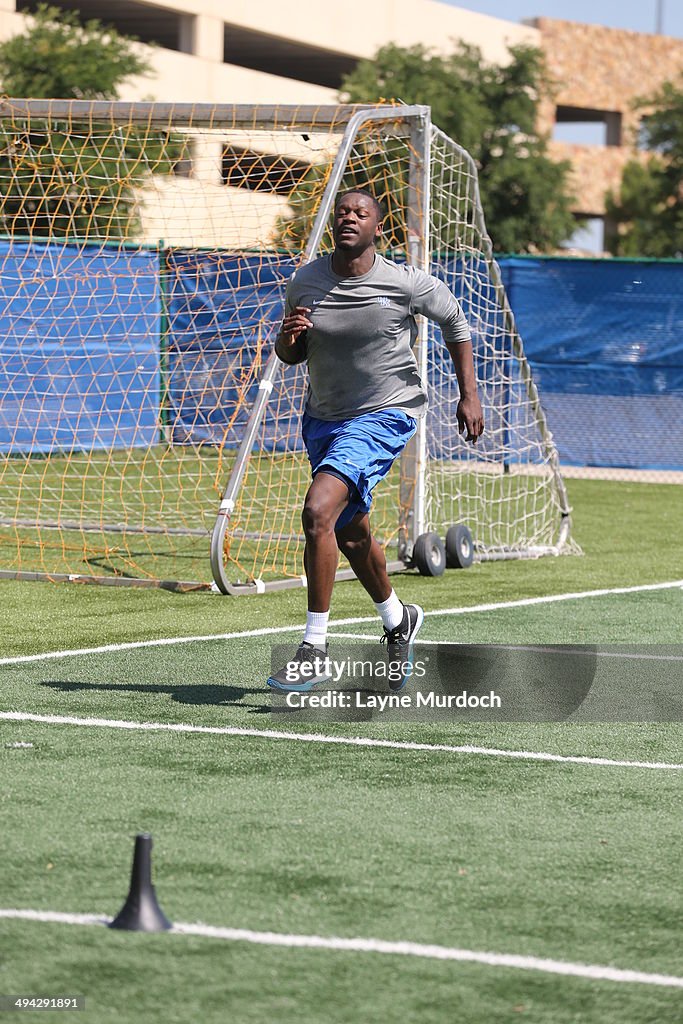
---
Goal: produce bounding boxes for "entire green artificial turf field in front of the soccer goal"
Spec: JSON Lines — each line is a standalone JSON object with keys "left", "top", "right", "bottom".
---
{"left": 0, "top": 480, "right": 683, "bottom": 1024}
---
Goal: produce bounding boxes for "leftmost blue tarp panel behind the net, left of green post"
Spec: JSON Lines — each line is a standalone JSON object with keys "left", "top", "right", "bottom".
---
{"left": 0, "top": 242, "right": 161, "bottom": 454}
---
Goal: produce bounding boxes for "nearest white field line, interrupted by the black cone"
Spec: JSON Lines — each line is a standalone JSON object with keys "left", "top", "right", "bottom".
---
{"left": 0, "top": 909, "right": 683, "bottom": 988}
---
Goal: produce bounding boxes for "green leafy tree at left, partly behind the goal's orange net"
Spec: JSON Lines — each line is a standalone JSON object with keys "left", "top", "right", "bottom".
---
{"left": 0, "top": 4, "right": 178, "bottom": 241}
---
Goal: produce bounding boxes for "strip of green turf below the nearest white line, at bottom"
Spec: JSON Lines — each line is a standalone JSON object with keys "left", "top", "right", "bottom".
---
{"left": 0, "top": 922, "right": 680, "bottom": 1024}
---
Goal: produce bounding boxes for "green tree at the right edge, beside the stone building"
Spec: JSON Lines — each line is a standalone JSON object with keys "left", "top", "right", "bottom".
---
{"left": 605, "top": 80, "right": 683, "bottom": 259}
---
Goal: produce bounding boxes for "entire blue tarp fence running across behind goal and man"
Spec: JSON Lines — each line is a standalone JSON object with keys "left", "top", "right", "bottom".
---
{"left": 0, "top": 242, "right": 683, "bottom": 470}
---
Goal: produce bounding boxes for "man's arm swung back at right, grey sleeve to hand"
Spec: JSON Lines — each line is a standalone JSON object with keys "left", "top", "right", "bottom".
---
{"left": 413, "top": 271, "right": 483, "bottom": 444}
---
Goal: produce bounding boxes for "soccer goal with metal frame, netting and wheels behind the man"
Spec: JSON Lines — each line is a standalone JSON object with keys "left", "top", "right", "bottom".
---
{"left": 0, "top": 99, "right": 578, "bottom": 594}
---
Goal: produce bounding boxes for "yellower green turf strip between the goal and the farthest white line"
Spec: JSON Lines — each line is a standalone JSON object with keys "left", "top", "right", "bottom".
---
{"left": 0, "top": 480, "right": 683, "bottom": 656}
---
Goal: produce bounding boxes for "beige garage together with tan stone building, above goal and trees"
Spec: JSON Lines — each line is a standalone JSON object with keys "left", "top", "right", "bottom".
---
{"left": 0, "top": 0, "right": 683, "bottom": 250}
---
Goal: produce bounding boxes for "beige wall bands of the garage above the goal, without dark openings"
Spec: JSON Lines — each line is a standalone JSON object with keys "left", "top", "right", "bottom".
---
{"left": 0, "top": 0, "right": 539, "bottom": 103}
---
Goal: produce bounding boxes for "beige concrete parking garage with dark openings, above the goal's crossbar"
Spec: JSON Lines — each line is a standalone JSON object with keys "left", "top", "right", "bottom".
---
{"left": 0, "top": 0, "right": 538, "bottom": 103}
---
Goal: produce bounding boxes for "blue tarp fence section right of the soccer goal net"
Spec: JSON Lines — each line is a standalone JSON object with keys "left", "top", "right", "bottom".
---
{"left": 501, "top": 257, "right": 683, "bottom": 470}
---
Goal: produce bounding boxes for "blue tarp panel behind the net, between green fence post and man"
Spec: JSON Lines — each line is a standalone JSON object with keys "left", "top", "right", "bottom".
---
{"left": 166, "top": 250, "right": 302, "bottom": 452}
